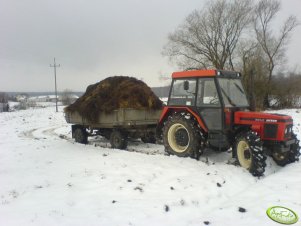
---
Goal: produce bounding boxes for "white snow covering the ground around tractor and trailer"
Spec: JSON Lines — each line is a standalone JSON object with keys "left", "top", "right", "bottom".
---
{"left": 0, "top": 106, "right": 301, "bottom": 226}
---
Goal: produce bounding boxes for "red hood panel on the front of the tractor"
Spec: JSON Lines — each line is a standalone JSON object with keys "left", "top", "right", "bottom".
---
{"left": 235, "top": 111, "right": 293, "bottom": 124}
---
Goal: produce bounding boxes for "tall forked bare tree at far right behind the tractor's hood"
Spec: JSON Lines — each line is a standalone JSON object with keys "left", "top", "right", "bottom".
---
{"left": 254, "top": 0, "right": 298, "bottom": 107}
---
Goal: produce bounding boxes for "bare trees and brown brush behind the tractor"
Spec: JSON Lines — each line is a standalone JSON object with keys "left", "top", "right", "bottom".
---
{"left": 162, "top": 0, "right": 301, "bottom": 109}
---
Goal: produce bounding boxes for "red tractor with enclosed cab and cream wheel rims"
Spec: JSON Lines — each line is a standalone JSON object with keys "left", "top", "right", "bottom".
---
{"left": 158, "top": 70, "right": 300, "bottom": 176}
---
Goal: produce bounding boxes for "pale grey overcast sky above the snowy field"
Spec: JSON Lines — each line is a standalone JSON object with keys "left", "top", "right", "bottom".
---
{"left": 0, "top": 0, "right": 301, "bottom": 92}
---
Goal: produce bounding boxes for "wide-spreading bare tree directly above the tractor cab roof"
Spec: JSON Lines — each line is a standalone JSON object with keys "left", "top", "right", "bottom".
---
{"left": 163, "top": 0, "right": 252, "bottom": 70}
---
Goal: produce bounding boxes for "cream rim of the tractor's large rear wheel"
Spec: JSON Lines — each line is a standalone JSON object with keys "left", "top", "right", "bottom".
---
{"left": 167, "top": 123, "right": 190, "bottom": 153}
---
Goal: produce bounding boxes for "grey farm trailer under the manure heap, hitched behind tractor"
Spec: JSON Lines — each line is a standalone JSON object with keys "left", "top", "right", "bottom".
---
{"left": 65, "top": 108, "right": 161, "bottom": 149}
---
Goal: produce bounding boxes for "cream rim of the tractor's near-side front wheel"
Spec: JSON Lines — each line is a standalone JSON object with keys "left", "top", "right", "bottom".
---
{"left": 237, "top": 140, "right": 252, "bottom": 169}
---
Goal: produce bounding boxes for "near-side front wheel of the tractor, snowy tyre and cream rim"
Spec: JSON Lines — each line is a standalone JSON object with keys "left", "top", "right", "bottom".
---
{"left": 233, "top": 131, "right": 266, "bottom": 176}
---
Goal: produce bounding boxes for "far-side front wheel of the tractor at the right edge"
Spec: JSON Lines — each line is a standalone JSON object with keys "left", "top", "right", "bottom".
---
{"left": 272, "top": 134, "right": 300, "bottom": 166}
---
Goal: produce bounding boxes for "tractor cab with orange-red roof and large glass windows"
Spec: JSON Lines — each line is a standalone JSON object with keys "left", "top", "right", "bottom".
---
{"left": 167, "top": 70, "right": 249, "bottom": 132}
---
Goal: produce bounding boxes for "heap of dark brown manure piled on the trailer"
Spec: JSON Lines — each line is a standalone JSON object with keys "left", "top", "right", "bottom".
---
{"left": 64, "top": 76, "right": 162, "bottom": 122}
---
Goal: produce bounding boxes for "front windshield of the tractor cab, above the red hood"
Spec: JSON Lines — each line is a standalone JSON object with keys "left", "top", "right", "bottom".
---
{"left": 218, "top": 78, "right": 249, "bottom": 107}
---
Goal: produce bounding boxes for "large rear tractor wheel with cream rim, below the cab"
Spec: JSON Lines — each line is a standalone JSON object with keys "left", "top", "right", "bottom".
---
{"left": 163, "top": 115, "right": 201, "bottom": 158}
